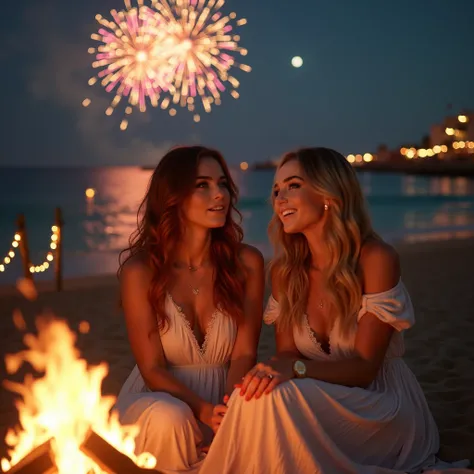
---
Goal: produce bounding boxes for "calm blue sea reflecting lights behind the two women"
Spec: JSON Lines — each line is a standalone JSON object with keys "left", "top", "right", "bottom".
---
{"left": 0, "top": 168, "right": 474, "bottom": 284}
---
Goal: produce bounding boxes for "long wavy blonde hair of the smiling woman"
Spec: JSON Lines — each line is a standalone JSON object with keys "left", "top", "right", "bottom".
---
{"left": 269, "top": 148, "right": 378, "bottom": 335}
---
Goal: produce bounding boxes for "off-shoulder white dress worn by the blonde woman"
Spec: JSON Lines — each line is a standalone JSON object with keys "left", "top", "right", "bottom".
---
{"left": 200, "top": 281, "right": 468, "bottom": 474}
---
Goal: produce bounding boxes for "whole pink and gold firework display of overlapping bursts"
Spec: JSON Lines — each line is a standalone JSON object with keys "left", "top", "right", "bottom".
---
{"left": 83, "top": 0, "right": 251, "bottom": 130}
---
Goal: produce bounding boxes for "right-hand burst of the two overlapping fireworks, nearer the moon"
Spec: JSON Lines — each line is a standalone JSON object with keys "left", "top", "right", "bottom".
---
{"left": 152, "top": 0, "right": 251, "bottom": 121}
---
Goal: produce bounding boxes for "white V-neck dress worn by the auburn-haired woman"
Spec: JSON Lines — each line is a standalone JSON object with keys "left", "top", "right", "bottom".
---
{"left": 115, "top": 294, "right": 237, "bottom": 474}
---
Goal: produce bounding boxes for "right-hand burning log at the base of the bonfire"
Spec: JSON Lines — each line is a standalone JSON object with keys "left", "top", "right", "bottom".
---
{"left": 80, "top": 430, "right": 159, "bottom": 474}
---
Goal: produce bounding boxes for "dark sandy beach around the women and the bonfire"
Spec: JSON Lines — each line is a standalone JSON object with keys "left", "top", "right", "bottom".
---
{"left": 0, "top": 240, "right": 474, "bottom": 461}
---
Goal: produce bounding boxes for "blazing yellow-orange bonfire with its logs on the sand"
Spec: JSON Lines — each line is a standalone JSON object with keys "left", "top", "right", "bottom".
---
{"left": 1, "top": 290, "right": 156, "bottom": 474}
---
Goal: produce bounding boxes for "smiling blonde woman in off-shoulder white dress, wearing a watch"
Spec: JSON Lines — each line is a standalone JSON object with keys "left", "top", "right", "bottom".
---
{"left": 201, "top": 148, "right": 467, "bottom": 474}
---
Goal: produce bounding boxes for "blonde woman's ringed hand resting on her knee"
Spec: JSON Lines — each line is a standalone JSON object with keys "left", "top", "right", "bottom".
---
{"left": 240, "top": 359, "right": 295, "bottom": 400}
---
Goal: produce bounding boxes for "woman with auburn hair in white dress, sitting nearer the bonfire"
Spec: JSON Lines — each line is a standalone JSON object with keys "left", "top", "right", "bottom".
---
{"left": 116, "top": 146, "right": 264, "bottom": 472}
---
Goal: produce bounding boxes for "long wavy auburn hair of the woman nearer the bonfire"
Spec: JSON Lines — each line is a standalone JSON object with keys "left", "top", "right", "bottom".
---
{"left": 118, "top": 146, "right": 244, "bottom": 330}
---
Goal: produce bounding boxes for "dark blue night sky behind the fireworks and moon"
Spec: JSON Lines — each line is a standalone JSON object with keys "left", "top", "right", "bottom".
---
{"left": 0, "top": 0, "right": 474, "bottom": 166}
